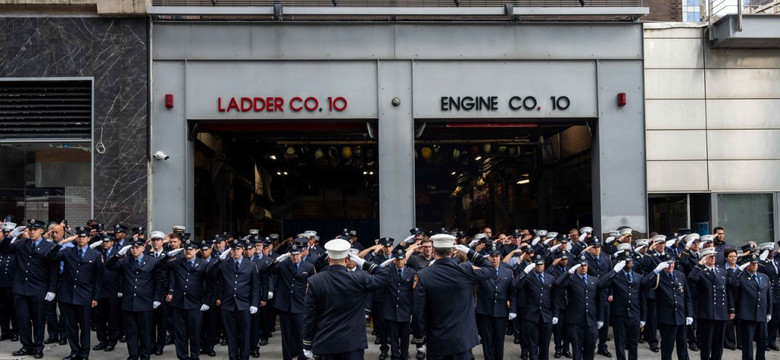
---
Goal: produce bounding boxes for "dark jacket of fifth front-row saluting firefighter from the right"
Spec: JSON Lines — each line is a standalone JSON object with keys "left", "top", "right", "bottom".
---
{"left": 555, "top": 271, "right": 601, "bottom": 327}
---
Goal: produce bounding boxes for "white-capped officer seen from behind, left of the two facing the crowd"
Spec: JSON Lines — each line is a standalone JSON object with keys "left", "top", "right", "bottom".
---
{"left": 304, "top": 239, "right": 394, "bottom": 360}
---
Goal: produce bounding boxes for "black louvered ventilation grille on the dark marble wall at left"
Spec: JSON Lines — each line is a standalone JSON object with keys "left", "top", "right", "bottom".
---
{"left": 0, "top": 80, "right": 92, "bottom": 139}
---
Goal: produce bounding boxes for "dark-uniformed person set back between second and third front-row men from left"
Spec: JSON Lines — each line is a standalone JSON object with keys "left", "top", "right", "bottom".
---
{"left": 92, "top": 234, "right": 122, "bottom": 351}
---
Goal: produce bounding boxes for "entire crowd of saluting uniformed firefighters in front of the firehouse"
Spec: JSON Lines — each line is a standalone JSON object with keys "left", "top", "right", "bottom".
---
{"left": 0, "top": 219, "right": 780, "bottom": 360}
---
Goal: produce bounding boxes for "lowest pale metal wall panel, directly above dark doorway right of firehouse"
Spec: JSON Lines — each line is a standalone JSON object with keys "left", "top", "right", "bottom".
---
{"left": 647, "top": 160, "right": 709, "bottom": 193}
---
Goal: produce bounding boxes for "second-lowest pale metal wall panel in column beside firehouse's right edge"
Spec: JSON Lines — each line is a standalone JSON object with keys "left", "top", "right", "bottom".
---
{"left": 646, "top": 130, "right": 707, "bottom": 161}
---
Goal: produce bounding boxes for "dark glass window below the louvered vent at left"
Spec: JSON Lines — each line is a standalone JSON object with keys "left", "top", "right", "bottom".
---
{"left": 0, "top": 142, "right": 92, "bottom": 226}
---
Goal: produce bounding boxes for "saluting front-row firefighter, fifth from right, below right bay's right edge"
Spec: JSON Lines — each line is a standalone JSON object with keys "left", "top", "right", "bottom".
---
{"left": 555, "top": 257, "right": 602, "bottom": 360}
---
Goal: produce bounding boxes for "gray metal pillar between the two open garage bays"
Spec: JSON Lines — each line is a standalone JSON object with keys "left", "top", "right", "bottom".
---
{"left": 376, "top": 61, "right": 415, "bottom": 239}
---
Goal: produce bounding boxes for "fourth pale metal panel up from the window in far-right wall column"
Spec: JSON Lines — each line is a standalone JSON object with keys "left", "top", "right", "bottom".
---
{"left": 705, "top": 69, "right": 780, "bottom": 99}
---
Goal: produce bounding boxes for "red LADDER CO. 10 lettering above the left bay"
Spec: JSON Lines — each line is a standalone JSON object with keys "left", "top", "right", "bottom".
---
{"left": 217, "top": 96, "right": 347, "bottom": 113}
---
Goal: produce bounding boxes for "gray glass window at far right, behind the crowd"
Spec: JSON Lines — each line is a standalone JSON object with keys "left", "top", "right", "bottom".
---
{"left": 717, "top": 194, "right": 775, "bottom": 247}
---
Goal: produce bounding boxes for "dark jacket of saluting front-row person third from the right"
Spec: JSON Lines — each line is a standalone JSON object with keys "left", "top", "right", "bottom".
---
{"left": 643, "top": 270, "right": 694, "bottom": 325}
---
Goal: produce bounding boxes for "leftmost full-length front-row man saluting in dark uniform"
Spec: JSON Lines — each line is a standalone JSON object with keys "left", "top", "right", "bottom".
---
{"left": 0, "top": 219, "right": 59, "bottom": 358}
